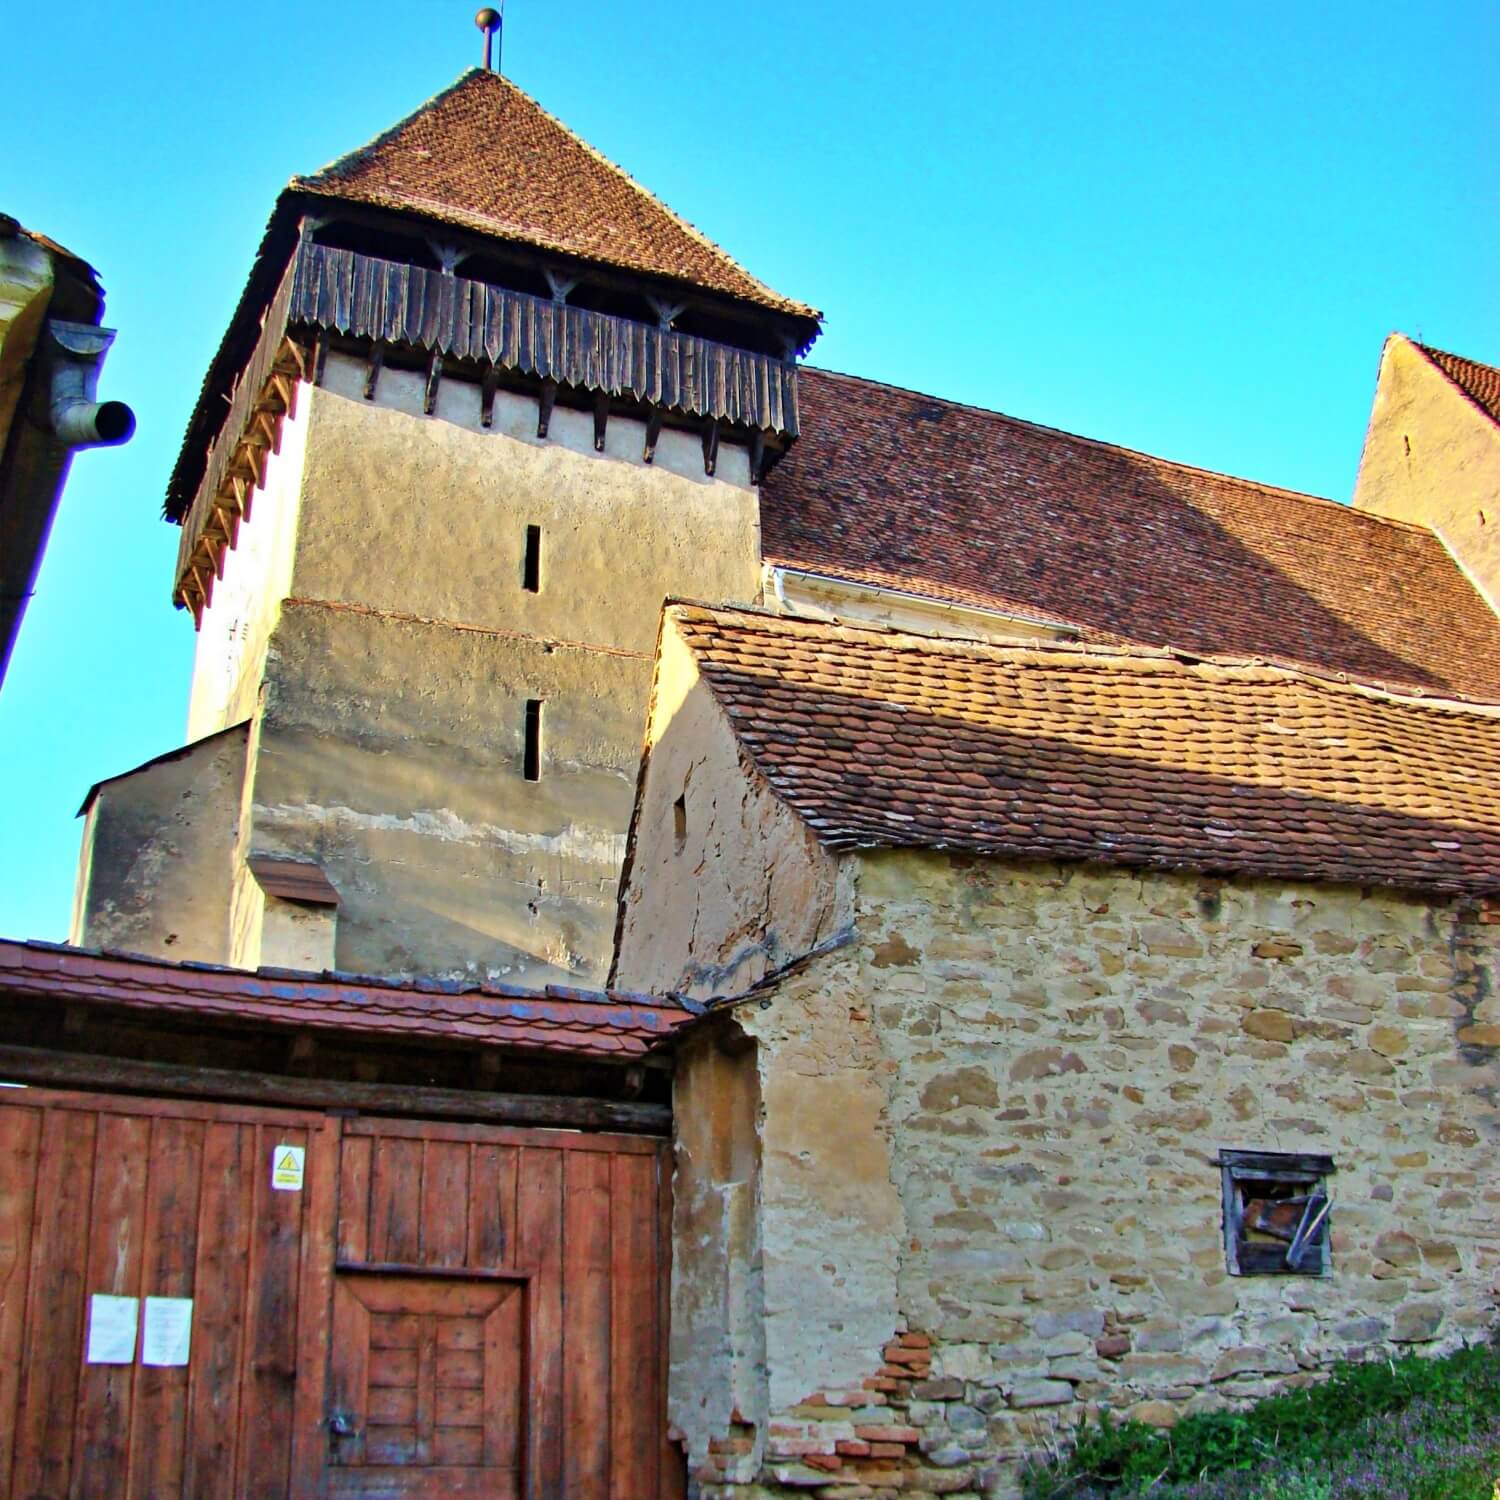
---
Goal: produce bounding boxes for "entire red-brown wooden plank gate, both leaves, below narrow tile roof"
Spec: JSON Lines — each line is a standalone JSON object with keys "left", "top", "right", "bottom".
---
{"left": 0, "top": 1089, "right": 683, "bottom": 1500}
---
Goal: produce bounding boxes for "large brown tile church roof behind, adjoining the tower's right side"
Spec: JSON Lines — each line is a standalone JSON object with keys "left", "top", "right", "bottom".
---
{"left": 761, "top": 366, "right": 1500, "bottom": 699}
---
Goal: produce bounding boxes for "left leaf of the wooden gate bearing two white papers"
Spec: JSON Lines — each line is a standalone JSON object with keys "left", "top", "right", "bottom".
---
{"left": 0, "top": 1089, "right": 333, "bottom": 1500}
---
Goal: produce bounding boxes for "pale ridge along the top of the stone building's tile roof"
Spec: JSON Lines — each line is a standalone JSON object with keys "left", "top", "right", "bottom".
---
{"left": 665, "top": 599, "right": 1500, "bottom": 719}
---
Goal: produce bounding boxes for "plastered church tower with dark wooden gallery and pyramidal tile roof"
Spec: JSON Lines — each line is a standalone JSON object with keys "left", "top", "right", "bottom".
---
{"left": 74, "top": 69, "right": 819, "bottom": 984}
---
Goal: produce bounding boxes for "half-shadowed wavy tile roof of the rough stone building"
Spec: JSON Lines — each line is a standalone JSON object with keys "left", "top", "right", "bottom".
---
{"left": 671, "top": 605, "right": 1500, "bottom": 893}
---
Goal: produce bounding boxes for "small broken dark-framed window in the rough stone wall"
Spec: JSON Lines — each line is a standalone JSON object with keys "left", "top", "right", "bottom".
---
{"left": 1220, "top": 1151, "right": 1334, "bottom": 1277}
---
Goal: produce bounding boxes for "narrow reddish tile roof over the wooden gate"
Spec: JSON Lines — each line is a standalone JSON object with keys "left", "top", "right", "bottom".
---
{"left": 0, "top": 939, "right": 690, "bottom": 1061}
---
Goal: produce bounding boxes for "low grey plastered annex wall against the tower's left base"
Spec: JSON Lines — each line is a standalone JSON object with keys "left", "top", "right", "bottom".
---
{"left": 69, "top": 725, "right": 246, "bottom": 963}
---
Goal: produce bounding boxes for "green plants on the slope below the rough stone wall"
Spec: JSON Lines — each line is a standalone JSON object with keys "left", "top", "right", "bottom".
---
{"left": 1025, "top": 1341, "right": 1500, "bottom": 1500}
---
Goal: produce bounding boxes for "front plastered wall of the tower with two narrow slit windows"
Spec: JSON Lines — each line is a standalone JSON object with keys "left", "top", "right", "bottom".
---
{"left": 213, "top": 356, "right": 759, "bottom": 983}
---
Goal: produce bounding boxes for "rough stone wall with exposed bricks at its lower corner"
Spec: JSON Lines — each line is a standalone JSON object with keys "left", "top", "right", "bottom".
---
{"left": 680, "top": 852, "right": 1500, "bottom": 1500}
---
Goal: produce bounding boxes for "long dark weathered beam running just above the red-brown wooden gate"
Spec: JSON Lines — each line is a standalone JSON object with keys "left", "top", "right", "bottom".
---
{"left": 0, "top": 1044, "right": 672, "bottom": 1136}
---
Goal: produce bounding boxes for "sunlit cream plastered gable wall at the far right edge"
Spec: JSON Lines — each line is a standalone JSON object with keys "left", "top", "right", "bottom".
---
{"left": 1355, "top": 335, "right": 1500, "bottom": 609}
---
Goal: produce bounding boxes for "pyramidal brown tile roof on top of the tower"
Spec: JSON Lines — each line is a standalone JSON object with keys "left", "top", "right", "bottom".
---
{"left": 291, "top": 69, "right": 818, "bottom": 318}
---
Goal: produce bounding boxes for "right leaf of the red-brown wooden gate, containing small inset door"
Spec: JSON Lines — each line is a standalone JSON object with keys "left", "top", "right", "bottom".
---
{"left": 324, "top": 1119, "right": 683, "bottom": 1500}
